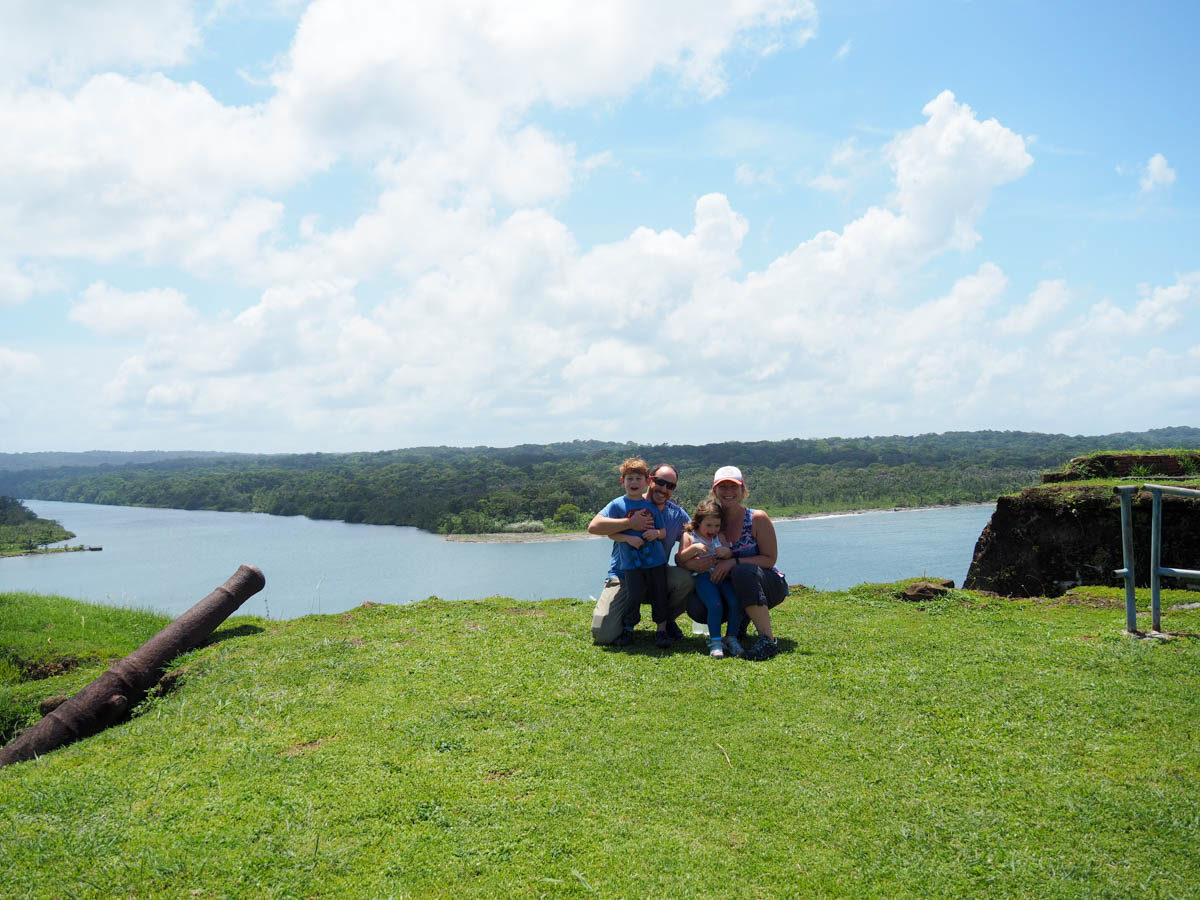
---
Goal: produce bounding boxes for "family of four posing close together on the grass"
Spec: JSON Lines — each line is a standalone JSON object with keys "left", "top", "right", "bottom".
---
{"left": 588, "top": 457, "right": 787, "bottom": 660}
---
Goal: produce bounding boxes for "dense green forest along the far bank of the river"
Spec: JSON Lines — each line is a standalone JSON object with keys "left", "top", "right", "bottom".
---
{"left": 0, "top": 427, "right": 1200, "bottom": 533}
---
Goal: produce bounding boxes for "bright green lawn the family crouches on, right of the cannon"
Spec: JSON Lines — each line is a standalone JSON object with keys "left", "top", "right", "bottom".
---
{"left": 0, "top": 586, "right": 1200, "bottom": 898}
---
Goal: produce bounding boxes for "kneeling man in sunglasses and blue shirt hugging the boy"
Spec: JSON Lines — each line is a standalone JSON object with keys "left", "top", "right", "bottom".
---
{"left": 588, "top": 463, "right": 696, "bottom": 644}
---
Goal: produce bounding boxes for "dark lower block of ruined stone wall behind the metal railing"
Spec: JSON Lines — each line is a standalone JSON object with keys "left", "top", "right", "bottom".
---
{"left": 964, "top": 480, "right": 1200, "bottom": 596}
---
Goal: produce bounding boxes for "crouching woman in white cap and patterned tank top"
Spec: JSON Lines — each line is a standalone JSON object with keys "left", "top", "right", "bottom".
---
{"left": 709, "top": 466, "right": 787, "bottom": 660}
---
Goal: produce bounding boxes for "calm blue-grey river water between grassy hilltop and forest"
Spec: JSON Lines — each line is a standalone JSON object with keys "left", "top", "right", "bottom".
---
{"left": 0, "top": 500, "right": 994, "bottom": 619}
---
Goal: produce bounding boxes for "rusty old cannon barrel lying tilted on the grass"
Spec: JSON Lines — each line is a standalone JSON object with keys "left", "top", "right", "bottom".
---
{"left": 0, "top": 565, "right": 266, "bottom": 766}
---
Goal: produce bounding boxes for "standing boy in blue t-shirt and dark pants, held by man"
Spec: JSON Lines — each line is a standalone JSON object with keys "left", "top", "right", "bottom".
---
{"left": 600, "top": 457, "right": 671, "bottom": 647}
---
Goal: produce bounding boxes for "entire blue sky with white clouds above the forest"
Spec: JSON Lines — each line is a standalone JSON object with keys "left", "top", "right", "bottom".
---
{"left": 0, "top": 0, "right": 1200, "bottom": 452}
